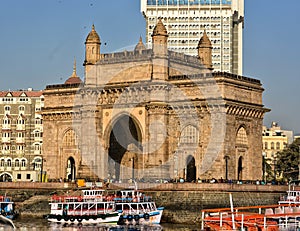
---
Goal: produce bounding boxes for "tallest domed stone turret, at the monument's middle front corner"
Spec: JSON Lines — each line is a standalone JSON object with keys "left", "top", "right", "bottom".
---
{"left": 152, "top": 19, "right": 169, "bottom": 80}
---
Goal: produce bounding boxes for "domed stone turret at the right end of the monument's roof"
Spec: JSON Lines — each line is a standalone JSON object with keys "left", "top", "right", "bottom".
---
{"left": 197, "top": 31, "right": 213, "bottom": 70}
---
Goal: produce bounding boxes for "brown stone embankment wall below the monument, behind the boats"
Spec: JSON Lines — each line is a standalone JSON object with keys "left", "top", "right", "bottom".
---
{"left": 0, "top": 183, "right": 292, "bottom": 224}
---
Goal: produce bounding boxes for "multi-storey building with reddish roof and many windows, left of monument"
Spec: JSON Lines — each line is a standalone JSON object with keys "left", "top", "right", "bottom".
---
{"left": 0, "top": 89, "right": 44, "bottom": 182}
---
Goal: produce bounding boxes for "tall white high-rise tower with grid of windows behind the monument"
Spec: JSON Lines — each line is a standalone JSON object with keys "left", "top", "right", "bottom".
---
{"left": 141, "top": 0, "right": 244, "bottom": 75}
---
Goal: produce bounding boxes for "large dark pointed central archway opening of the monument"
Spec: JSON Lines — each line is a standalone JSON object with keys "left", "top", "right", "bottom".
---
{"left": 108, "top": 115, "right": 142, "bottom": 180}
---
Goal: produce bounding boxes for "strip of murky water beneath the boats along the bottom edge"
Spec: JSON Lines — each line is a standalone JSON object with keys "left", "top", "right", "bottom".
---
{"left": 0, "top": 218, "right": 200, "bottom": 231}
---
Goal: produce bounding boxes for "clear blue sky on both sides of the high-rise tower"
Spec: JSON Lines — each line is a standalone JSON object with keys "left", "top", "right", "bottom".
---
{"left": 0, "top": 0, "right": 300, "bottom": 133}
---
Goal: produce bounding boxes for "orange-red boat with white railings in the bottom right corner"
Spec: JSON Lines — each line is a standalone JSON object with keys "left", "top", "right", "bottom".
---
{"left": 201, "top": 190, "right": 300, "bottom": 231}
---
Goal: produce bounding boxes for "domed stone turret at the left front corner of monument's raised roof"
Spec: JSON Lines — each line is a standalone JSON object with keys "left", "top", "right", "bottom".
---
{"left": 83, "top": 25, "right": 101, "bottom": 72}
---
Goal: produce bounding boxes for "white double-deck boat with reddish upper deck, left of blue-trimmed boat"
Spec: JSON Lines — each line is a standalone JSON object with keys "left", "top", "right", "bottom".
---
{"left": 46, "top": 189, "right": 121, "bottom": 224}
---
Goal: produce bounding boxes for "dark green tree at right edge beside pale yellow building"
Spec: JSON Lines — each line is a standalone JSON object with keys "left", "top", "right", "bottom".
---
{"left": 276, "top": 139, "right": 300, "bottom": 181}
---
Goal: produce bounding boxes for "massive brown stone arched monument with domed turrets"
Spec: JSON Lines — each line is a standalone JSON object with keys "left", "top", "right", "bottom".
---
{"left": 42, "top": 20, "right": 269, "bottom": 182}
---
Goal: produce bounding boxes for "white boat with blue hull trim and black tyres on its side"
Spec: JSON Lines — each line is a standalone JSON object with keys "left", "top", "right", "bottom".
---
{"left": 114, "top": 189, "right": 164, "bottom": 225}
